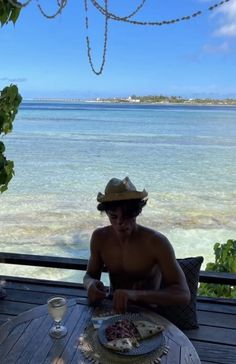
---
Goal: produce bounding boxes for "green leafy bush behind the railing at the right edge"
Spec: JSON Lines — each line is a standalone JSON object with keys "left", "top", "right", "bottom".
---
{"left": 198, "top": 239, "right": 236, "bottom": 298}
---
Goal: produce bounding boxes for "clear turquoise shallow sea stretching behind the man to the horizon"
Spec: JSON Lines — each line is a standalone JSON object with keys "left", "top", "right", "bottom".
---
{"left": 0, "top": 102, "right": 236, "bottom": 280}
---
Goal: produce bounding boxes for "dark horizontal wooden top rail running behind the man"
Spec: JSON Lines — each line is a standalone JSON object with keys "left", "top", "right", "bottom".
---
{"left": 0, "top": 253, "right": 236, "bottom": 286}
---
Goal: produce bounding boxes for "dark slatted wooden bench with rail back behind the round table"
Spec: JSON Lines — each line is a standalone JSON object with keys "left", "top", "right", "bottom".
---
{"left": 0, "top": 253, "right": 236, "bottom": 364}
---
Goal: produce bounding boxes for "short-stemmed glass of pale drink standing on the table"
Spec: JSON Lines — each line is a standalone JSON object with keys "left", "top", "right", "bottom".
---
{"left": 48, "top": 297, "right": 67, "bottom": 339}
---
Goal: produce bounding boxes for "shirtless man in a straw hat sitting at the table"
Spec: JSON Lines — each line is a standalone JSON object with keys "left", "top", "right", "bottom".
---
{"left": 84, "top": 177, "right": 190, "bottom": 313}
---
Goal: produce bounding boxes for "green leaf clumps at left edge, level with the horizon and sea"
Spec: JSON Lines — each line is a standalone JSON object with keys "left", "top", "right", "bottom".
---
{"left": 0, "top": 85, "right": 22, "bottom": 193}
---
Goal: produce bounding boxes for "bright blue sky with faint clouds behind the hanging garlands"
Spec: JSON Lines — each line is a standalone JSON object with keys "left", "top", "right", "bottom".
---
{"left": 0, "top": 0, "right": 236, "bottom": 99}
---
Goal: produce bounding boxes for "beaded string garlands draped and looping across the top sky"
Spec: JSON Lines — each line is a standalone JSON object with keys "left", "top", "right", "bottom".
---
{"left": 8, "top": 0, "right": 234, "bottom": 75}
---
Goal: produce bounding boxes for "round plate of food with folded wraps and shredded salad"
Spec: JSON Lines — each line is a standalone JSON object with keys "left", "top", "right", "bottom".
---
{"left": 98, "top": 314, "right": 165, "bottom": 355}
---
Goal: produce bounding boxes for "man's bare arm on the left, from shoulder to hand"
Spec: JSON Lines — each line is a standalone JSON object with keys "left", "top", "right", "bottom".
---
{"left": 83, "top": 230, "right": 106, "bottom": 303}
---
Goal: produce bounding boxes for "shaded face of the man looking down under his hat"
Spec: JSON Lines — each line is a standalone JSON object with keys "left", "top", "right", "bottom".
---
{"left": 107, "top": 207, "right": 136, "bottom": 235}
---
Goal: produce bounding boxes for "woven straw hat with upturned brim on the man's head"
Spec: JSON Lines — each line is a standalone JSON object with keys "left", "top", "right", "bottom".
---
{"left": 97, "top": 177, "right": 148, "bottom": 202}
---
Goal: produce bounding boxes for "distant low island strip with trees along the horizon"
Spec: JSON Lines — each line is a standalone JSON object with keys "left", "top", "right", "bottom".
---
{"left": 29, "top": 95, "right": 236, "bottom": 106}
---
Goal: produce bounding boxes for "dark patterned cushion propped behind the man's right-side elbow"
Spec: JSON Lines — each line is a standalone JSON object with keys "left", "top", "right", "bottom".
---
{"left": 158, "top": 257, "right": 203, "bottom": 330}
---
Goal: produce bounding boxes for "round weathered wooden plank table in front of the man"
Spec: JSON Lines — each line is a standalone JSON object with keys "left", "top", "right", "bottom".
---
{"left": 0, "top": 299, "right": 200, "bottom": 364}
